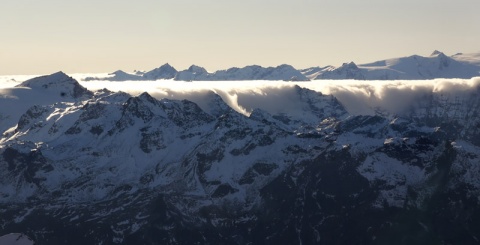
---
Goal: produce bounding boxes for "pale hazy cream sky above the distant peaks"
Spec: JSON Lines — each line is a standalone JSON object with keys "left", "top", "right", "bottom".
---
{"left": 0, "top": 0, "right": 480, "bottom": 75}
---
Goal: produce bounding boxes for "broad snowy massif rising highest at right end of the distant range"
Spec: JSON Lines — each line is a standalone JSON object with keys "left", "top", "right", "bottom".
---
{"left": 305, "top": 50, "right": 480, "bottom": 80}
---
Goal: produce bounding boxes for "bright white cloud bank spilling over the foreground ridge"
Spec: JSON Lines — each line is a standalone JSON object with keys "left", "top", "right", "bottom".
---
{"left": 0, "top": 74, "right": 480, "bottom": 115}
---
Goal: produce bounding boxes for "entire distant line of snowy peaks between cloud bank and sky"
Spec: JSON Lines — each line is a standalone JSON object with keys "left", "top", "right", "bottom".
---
{"left": 86, "top": 50, "right": 480, "bottom": 81}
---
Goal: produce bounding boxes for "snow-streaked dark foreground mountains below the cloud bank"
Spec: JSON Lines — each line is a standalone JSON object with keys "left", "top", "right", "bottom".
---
{"left": 0, "top": 72, "right": 480, "bottom": 244}
